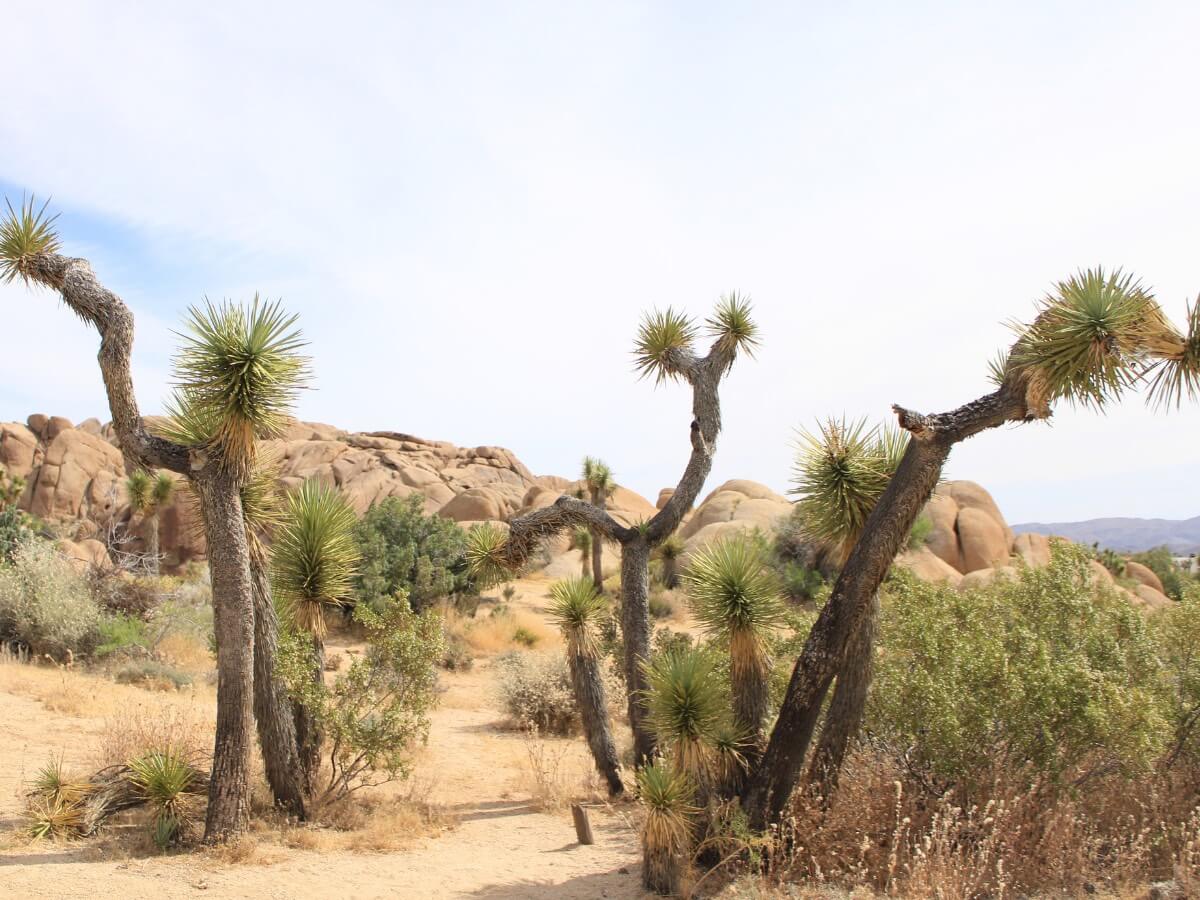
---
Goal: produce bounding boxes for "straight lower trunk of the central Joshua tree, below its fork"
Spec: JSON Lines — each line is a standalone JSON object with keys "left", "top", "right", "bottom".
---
{"left": 620, "top": 536, "right": 655, "bottom": 766}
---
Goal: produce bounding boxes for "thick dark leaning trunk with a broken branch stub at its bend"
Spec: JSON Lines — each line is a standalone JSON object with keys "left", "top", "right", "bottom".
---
{"left": 743, "top": 376, "right": 1050, "bottom": 829}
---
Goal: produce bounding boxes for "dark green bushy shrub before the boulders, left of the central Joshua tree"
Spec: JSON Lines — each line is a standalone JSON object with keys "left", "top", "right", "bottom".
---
{"left": 354, "top": 493, "right": 479, "bottom": 612}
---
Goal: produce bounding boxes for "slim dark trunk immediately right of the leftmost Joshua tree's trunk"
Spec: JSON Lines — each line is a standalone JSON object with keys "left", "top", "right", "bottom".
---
{"left": 250, "top": 553, "right": 306, "bottom": 820}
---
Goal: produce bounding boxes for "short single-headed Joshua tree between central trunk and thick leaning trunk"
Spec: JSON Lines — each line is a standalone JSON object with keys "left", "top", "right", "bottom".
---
{"left": 683, "top": 538, "right": 784, "bottom": 763}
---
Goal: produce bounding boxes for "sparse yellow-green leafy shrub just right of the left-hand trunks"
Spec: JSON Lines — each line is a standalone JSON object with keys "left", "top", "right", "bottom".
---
{"left": 277, "top": 593, "right": 445, "bottom": 804}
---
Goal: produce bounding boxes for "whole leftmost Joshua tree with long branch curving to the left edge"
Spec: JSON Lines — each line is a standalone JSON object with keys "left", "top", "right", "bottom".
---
{"left": 0, "top": 199, "right": 306, "bottom": 842}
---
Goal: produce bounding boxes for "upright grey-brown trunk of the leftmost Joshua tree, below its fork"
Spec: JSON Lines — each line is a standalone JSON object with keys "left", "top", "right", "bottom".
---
{"left": 196, "top": 468, "right": 254, "bottom": 844}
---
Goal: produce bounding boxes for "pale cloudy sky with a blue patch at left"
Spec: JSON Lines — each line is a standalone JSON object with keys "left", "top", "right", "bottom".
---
{"left": 0, "top": 0, "right": 1200, "bottom": 522}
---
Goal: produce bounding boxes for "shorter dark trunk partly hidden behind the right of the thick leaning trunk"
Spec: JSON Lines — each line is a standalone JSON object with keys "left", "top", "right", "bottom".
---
{"left": 809, "top": 592, "right": 880, "bottom": 793}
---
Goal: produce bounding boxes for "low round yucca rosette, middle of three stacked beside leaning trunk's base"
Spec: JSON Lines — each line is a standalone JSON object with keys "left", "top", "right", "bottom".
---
{"left": 642, "top": 648, "right": 727, "bottom": 786}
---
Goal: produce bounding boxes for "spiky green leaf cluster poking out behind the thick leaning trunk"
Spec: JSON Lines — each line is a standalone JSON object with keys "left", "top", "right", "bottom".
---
{"left": 791, "top": 419, "right": 908, "bottom": 557}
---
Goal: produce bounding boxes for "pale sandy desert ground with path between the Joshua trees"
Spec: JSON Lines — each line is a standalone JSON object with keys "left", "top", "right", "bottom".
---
{"left": 0, "top": 578, "right": 657, "bottom": 900}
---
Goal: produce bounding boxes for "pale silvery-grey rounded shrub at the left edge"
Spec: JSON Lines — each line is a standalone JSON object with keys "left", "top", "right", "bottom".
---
{"left": 0, "top": 540, "right": 100, "bottom": 659}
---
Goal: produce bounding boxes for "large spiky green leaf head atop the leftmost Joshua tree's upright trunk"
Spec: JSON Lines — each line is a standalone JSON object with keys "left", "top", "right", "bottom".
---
{"left": 167, "top": 296, "right": 308, "bottom": 478}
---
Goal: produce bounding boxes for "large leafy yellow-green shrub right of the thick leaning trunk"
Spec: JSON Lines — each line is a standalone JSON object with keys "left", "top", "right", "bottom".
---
{"left": 869, "top": 544, "right": 1169, "bottom": 782}
